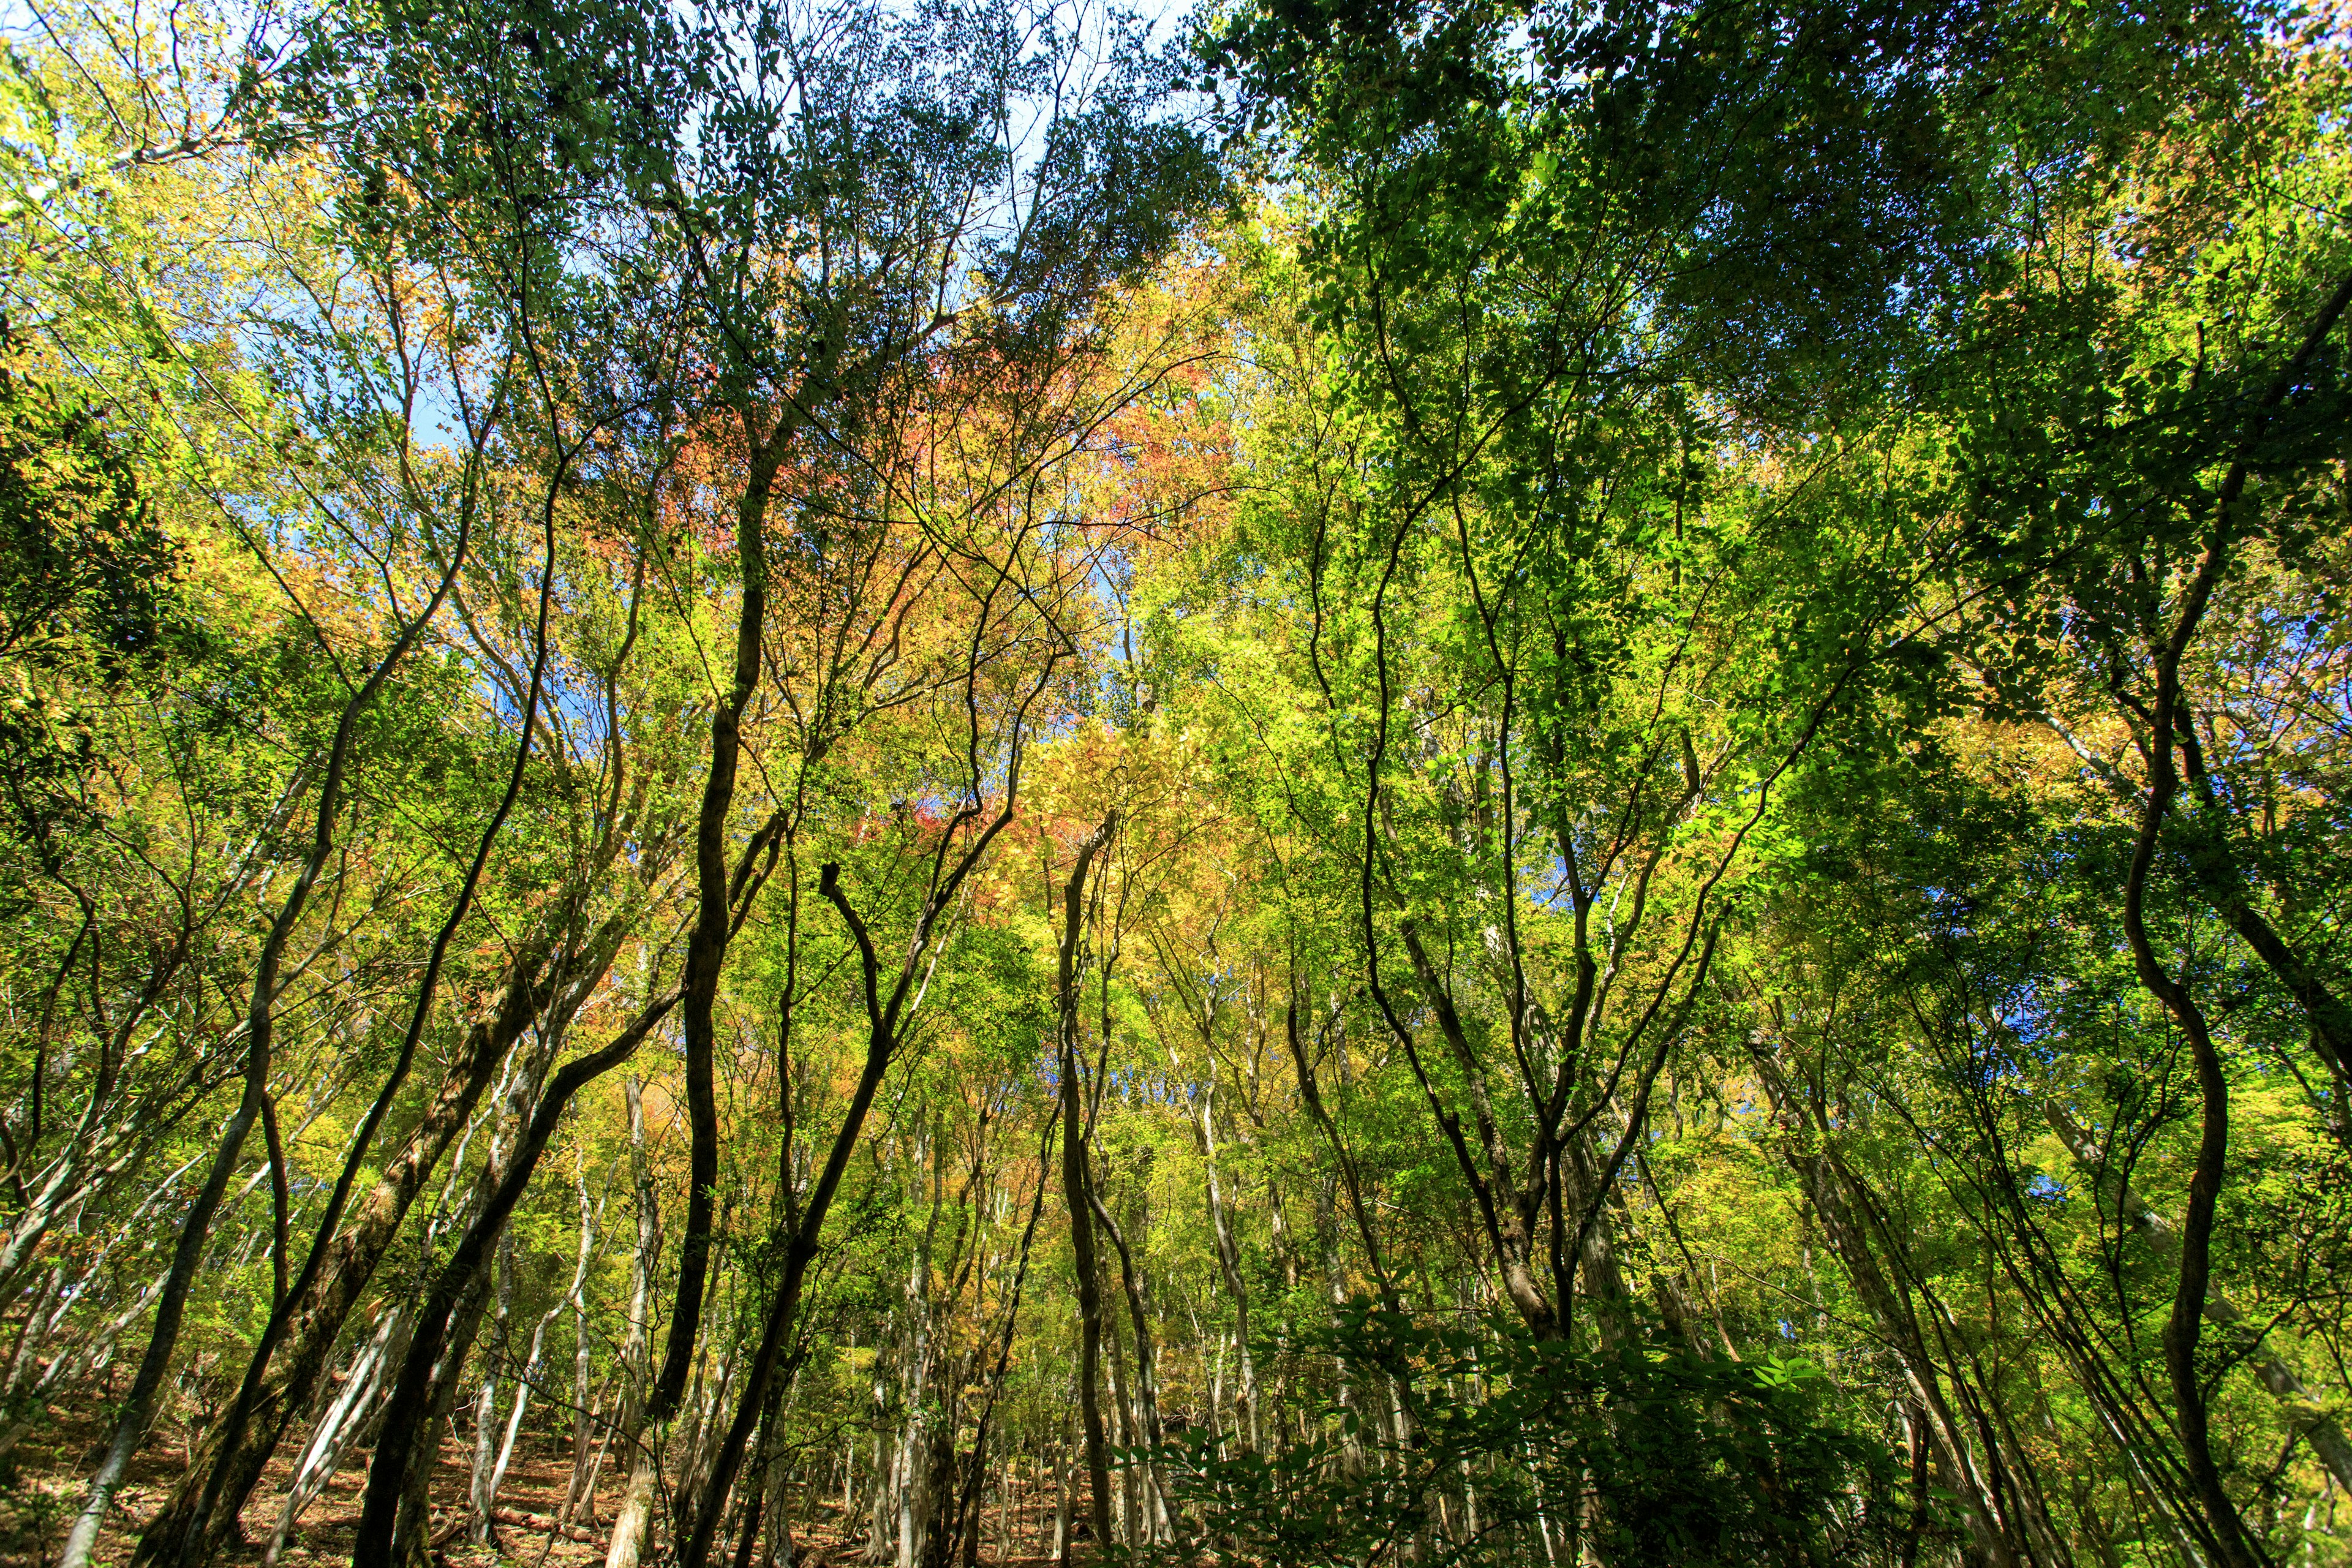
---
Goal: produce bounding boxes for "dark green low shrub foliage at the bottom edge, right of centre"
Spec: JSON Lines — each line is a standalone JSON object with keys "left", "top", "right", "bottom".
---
{"left": 1129, "top": 1298, "right": 1926, "bottom": 1568}
